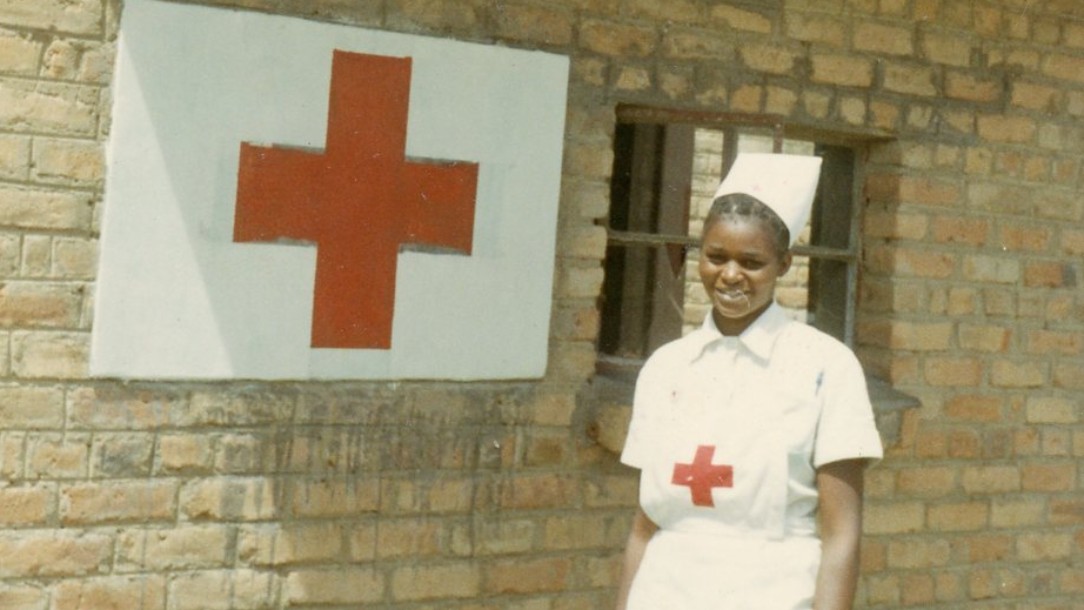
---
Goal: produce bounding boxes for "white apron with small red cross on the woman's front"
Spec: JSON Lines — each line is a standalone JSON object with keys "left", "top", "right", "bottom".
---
{"left": 628, "top": 338, "right": 821, "bottom": 610}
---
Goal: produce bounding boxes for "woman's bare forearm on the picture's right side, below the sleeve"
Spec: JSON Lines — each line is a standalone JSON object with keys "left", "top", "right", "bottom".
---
{"left": 813, "top": 459, "right": 866, "bottom": 610}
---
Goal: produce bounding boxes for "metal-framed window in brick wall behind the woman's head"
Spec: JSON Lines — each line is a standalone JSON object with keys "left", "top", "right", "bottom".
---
{"left": 599, "top": 106, "right": 861, "bottom": 374}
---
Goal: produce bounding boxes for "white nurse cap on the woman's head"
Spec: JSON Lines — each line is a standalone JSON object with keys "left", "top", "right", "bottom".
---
{"left": 714, "top": 153, "right": 821, "bottom": 246}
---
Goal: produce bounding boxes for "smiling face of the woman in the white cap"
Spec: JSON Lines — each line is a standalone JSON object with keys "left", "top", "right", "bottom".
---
{"left": 699, "top": 218, "right": 791, "bottom": 335}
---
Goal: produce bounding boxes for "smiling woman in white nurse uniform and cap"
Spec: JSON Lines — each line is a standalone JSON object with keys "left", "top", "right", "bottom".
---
{"left": 618, "top": 155, "right": 881, "bottom": 610}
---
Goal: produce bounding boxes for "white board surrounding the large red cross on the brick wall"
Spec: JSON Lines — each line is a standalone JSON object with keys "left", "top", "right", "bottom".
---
{"left": 90, "top": 0, "right": 568, "bottom": 379}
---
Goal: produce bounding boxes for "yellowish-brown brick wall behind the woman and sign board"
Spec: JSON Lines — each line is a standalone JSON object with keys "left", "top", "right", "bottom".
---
{"left": 0, "top": 0, "right": 1084, "bottom": 610}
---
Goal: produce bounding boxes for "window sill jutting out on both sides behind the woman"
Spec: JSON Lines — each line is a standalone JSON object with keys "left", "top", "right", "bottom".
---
{"left": 580, "top": 367, "right": 921, "bottom": 455}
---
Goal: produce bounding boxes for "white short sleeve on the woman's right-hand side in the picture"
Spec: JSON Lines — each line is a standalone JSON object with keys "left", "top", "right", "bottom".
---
{"left": 813, "top": 347, "right": 883, "bottom": 467}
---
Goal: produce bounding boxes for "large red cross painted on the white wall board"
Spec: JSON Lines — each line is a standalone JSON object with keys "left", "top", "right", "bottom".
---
{"left": 233, "top": 51, "right": 478, "bottom": 349}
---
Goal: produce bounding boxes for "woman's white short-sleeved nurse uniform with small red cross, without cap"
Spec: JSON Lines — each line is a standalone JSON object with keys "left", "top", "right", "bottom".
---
{"left": 621, "top": 304, "right": 881, "bottom": 610}
